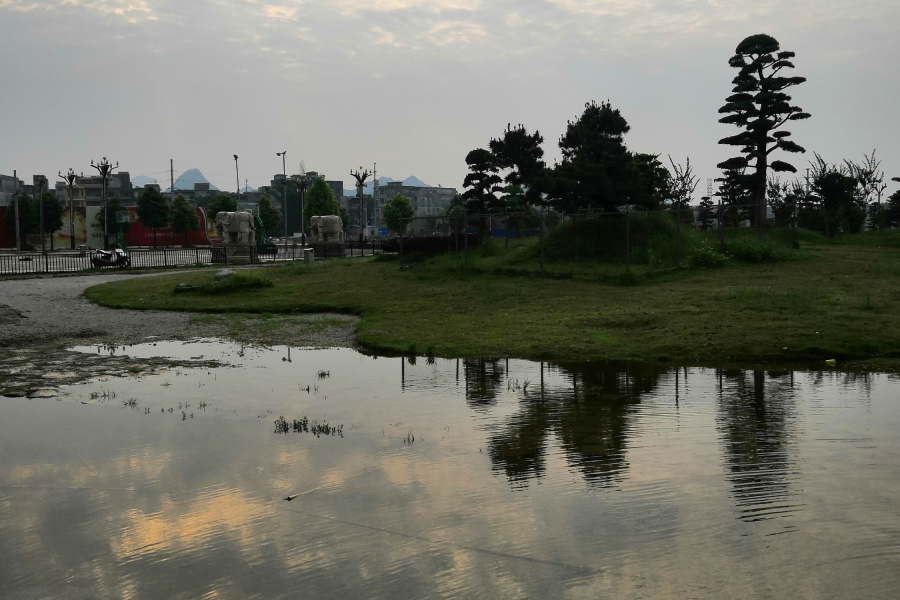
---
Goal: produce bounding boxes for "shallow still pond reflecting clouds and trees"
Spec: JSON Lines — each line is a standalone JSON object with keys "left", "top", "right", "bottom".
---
{"left": 0, "top": 341, "right": 900, "bottom": 599}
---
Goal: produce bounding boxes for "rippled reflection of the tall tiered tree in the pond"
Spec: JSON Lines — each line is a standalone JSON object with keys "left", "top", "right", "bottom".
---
{"left": 717, "top": 371, "right": 801, "bottom": 521}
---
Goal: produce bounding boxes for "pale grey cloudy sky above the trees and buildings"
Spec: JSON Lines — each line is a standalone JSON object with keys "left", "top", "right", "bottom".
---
{"left": 0, "top": 0, "right": 900, "bottom": 196}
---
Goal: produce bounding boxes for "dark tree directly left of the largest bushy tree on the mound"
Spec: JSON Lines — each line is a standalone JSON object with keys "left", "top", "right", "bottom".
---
{"left": 488, "top": 125, "right": 546, "bottom": 206}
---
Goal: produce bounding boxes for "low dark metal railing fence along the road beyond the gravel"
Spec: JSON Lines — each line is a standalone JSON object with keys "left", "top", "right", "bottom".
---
{"left": 0, "top": 240, "right": 384, "bottom": 275}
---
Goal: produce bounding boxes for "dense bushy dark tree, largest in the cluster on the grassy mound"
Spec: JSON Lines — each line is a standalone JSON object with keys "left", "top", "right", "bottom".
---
{"left": 556, "top": 102, "right": 631, "bottom": 210}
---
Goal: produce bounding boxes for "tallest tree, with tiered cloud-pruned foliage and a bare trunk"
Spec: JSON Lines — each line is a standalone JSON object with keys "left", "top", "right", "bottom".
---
{"left": 719, "top": 34, "right": 810, "bottom": 235}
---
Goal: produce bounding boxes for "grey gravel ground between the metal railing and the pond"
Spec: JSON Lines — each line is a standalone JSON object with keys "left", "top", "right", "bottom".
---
{"left": 0, "top": 271, "right": 357, "bottom": 348}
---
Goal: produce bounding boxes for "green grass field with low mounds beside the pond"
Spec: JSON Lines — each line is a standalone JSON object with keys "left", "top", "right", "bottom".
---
{"left": 85, "top": 231, "right": 900, "bottom": 371}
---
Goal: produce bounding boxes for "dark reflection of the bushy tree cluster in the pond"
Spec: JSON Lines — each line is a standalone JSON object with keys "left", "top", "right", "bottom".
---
{"left": 474, "top": 361, "right": 664, "bottom": 487}
